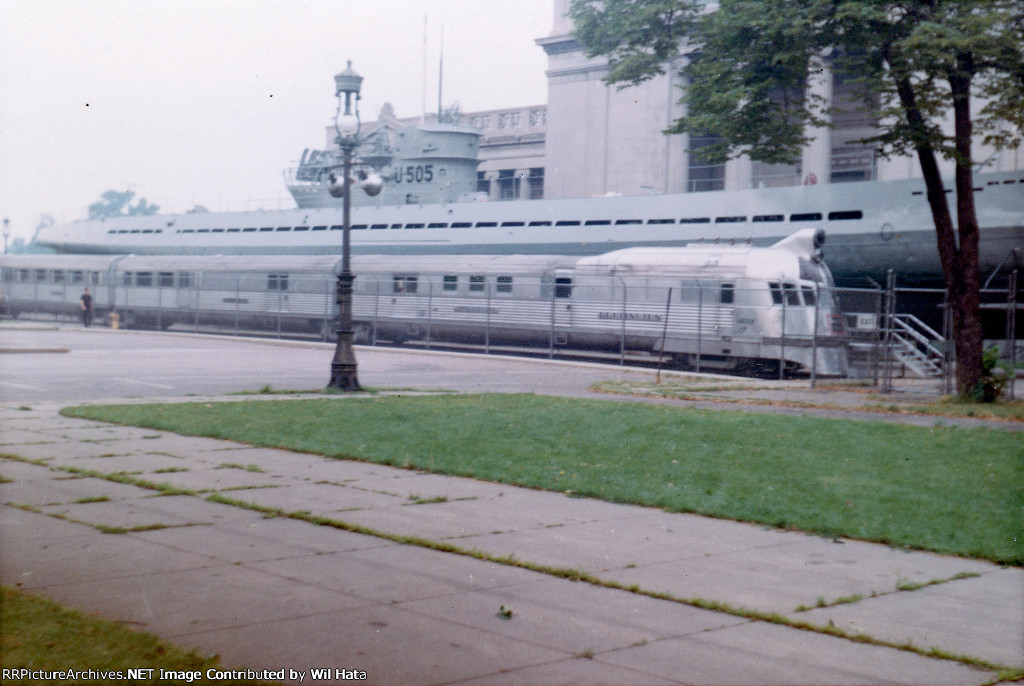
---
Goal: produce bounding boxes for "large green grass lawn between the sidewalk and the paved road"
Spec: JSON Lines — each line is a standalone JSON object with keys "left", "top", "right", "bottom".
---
{"left": 63, "top": 394, "right": 1024, "bottom": 565}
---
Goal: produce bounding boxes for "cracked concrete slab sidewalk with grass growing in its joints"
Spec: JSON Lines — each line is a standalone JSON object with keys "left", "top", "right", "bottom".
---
{"left": 0, "top": 398, "right": 1024, "bottom": 684}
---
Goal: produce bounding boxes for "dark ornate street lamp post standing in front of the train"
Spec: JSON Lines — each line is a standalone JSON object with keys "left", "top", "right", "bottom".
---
{"left": 328, "top": 60, "right": 362, "bottom": 391}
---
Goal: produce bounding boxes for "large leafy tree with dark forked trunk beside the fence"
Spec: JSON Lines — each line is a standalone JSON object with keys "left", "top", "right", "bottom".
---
{"left": 569, "top": 0, "right": 1024, "bottom": 395}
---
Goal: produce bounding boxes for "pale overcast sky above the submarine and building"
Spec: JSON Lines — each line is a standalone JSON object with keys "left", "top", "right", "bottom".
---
{"left": 0, "top": 0, "right": 554, "bottom": 240}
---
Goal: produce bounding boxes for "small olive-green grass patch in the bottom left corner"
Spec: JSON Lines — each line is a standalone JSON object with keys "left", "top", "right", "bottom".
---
{"left": 0, "top": 587, "right": 280, "bottom": 684}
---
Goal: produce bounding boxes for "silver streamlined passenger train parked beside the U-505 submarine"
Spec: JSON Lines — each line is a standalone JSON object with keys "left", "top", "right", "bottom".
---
{"left": 0, "top": 229, "right": 849, "bottom": 376}
